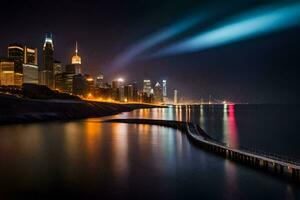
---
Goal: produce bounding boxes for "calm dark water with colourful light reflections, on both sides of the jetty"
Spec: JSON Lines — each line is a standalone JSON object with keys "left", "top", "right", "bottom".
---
{"left": 0, "top": 105, "right": 300, "bottom": 199}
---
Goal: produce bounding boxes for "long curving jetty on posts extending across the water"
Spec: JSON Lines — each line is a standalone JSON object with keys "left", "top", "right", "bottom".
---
{"left": 105, "top": 119, "right": 300, "bottom": 182}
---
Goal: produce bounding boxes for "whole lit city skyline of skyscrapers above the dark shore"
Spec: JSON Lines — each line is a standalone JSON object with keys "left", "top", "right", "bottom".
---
{"left": 0, "top": 34, "right": 175, "bottom": 104}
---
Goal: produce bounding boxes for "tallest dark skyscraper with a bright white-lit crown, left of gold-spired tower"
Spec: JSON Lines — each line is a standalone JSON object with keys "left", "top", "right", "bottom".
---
{"left": 39, "top": 35, "right": 54, "bottom": 89}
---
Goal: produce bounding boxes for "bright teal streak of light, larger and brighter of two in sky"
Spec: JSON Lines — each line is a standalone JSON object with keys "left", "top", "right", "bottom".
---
{"left": 151, "top": 2, "right": 300, "bottom": 57}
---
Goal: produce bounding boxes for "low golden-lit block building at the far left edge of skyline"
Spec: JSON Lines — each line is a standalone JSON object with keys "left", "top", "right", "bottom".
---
{"left": 0, "top": 59, "right": 22, "bottom": 86}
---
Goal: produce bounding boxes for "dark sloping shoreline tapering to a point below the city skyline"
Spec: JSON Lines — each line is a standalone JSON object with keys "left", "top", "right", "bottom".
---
{"left": 0, "top": 94, "right": 159, "bottom": 125}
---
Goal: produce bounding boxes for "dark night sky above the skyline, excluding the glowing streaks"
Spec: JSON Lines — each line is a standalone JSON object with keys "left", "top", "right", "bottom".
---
{"left": 0, "top": 0, "right": 300, "bottom": 103}
